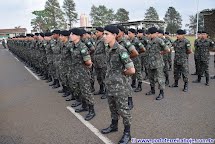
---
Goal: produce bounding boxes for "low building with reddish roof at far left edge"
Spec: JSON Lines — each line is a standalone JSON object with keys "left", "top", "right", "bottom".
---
{"left": 0, "top": 28, "right": 27, "bottom": 39}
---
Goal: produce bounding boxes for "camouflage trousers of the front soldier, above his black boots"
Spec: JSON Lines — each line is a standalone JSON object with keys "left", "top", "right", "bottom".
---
{"left": 108, "top": 96, "right": 132, "bottom": 125}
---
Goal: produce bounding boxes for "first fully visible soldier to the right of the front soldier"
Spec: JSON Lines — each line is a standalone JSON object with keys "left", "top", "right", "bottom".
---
{"left": 146, "top": 27, "right": 169, "bottom": 100}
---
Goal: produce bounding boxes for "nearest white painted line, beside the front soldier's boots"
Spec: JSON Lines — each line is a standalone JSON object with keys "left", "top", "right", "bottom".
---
{"left": 66, "top": 106, "right": 113, "bottom": 144}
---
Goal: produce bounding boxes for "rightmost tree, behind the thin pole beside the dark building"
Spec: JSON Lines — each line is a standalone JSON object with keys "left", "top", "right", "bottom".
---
{"left": 186, "top": 13, "right": 204, "bottom": 33}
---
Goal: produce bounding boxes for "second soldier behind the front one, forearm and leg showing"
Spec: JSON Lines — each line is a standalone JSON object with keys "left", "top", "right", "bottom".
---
{"left": 128, "top": 28, "right": 145, "bottom": 92}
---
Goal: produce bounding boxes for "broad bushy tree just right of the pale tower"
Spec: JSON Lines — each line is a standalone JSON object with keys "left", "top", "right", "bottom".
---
{"left": 90, "top": 5, "right": 114, "bottom": 26}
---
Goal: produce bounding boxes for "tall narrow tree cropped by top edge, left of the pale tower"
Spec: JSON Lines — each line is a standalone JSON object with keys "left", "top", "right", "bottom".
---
{"left": 63, "top": 0, "right": 78, "bottom": 28}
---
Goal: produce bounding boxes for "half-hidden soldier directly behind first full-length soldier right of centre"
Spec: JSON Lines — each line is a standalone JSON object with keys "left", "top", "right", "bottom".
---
{"left": 158, "top": 29, "right": 172, "bottom": 86}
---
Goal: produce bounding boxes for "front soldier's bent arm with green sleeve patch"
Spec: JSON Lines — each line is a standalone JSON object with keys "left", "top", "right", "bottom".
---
{"left": 120, "top": 50, "right": 135, "bottom": 75}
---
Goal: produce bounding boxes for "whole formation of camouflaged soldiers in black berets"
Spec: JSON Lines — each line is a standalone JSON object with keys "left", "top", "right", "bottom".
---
{"left": 8, "top": 25, "right": 214, "bottom": 143}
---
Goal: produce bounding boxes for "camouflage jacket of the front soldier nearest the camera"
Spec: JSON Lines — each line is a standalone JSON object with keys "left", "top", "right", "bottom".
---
{"left": 105, "top": 42, "right": 134, "bottom": 96}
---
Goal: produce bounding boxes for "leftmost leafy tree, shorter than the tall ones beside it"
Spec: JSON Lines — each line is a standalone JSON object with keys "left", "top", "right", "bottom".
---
{"left": 31, "top": 10, "right": 51, "bottom": 32}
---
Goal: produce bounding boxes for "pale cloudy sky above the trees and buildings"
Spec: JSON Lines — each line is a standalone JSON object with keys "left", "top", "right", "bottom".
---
{"left": 0, "top": 0, "right": 215, "bottom": 31}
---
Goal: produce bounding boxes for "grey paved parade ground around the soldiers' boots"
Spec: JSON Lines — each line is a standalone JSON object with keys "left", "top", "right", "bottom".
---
{"left": 0, "top": 45, "right": 215, "bottom": 144}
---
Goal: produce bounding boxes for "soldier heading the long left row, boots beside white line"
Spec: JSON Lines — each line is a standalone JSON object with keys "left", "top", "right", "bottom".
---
{"left": 68, "top": 28, "right": 96, "bottom": 121}
